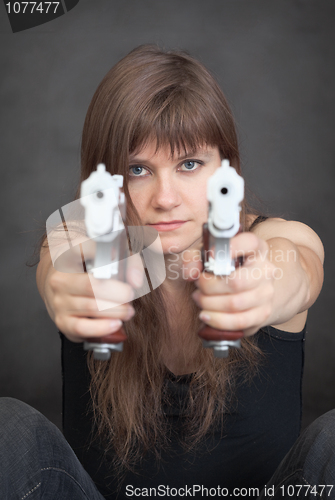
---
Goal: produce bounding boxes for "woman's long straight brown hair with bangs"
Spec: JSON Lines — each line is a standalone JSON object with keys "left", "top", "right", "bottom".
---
{"left": 81, "top": 45, "right": 259, "bottom": 471}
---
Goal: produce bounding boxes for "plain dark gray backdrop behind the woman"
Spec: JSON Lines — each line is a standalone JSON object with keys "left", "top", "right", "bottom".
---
{"left": 0, "top": 0, "right": 335, "bottom": 425}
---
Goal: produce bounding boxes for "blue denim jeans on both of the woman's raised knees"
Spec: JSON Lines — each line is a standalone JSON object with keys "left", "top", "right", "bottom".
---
{"left": 0, "top": 398, "right": 335, "bottom": 500}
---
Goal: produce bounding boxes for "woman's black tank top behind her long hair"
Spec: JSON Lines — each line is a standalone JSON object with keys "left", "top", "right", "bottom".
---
{"left": 61, "top": 327, "right": 305, "bottom": 499}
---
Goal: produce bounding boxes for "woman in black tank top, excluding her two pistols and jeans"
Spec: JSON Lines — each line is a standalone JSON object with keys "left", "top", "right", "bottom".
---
{"left": 0, "top": 46, "right": 330, "bottom": 498}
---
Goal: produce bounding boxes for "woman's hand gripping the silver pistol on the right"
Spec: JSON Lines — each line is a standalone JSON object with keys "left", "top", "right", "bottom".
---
{"left": 184, "top": 232, "right": 280, "bottom": 336}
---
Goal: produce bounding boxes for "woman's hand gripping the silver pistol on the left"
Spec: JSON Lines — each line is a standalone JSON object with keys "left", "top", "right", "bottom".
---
{"left": 36, "top": 248, "right": 144, "bottom": 342}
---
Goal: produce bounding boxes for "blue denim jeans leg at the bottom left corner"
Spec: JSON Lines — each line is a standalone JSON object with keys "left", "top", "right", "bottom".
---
{"left": 0, "top": 398, "right": 103, "bottom": 500}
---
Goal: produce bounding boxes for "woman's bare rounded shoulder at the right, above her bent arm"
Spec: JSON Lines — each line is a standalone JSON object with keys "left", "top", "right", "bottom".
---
{"left": 248, "top": 215, "right": 324, "bottom": 263}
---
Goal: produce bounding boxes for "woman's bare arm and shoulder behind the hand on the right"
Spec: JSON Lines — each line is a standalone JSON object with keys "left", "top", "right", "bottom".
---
{"left": 254, "top": 219, "right": 324, "bottom": 331}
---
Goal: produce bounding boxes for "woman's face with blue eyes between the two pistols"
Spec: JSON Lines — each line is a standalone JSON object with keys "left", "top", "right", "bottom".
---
{"left": 129, "top": 143, "right": 221, "bottom": 254}
